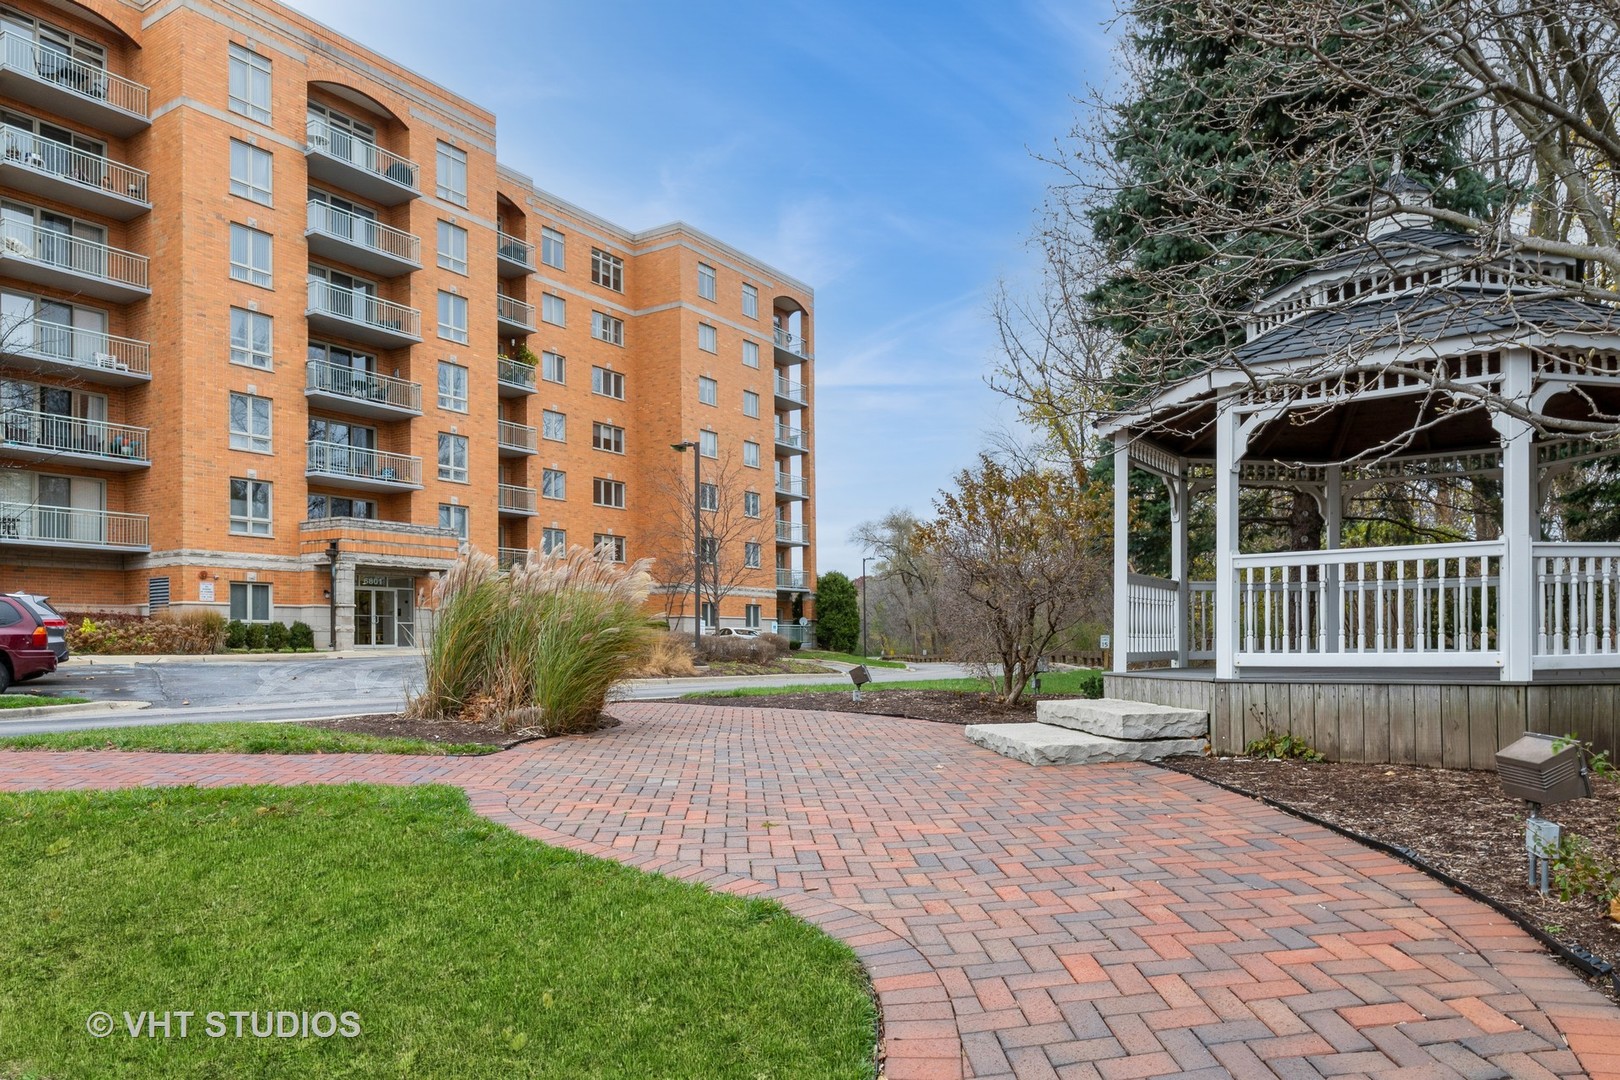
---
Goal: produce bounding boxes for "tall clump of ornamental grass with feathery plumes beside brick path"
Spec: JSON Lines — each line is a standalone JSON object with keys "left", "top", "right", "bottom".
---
{"left": 410, "top": 546, "right": 651, "bottom": 735}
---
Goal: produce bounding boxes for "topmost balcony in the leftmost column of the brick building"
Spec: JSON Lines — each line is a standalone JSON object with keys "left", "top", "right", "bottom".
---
{"left": 0, "top": 31, "right": 152, "bottom": 138}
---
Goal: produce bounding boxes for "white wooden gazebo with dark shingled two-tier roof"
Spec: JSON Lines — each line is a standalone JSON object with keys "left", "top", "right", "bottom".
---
{"left": 1103, "top": 188, "right": 1620, "bottom": 767}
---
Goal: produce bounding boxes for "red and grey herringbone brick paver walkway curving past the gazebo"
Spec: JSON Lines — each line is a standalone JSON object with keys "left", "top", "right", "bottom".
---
{"left": 0, "top": 704, "right": 1620, "bottom": 1080}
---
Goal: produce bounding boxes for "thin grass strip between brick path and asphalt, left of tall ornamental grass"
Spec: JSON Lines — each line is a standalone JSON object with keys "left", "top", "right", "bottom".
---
{"left": 0, "top": 722, "right": 501, "bottom": 755}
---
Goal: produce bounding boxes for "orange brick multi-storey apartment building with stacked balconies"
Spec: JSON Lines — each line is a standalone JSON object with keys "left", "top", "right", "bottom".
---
{"left": 0, "top": 0, "right": 815, "bottom": 646}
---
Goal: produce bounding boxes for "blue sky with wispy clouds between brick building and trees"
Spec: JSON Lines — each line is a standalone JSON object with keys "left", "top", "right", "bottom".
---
{"left": 292, "top": 0, "right": 1113, "bottom": 576}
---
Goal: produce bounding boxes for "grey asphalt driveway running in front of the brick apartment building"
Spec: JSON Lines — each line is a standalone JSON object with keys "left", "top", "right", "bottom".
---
{"left": 0, "top": 654, "right": 967, "bottom": 735}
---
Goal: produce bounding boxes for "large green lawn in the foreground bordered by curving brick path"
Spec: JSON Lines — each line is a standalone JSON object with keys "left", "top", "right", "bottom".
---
{"left": 0, "top": 785, "right": 876, "bottom": 1080}
